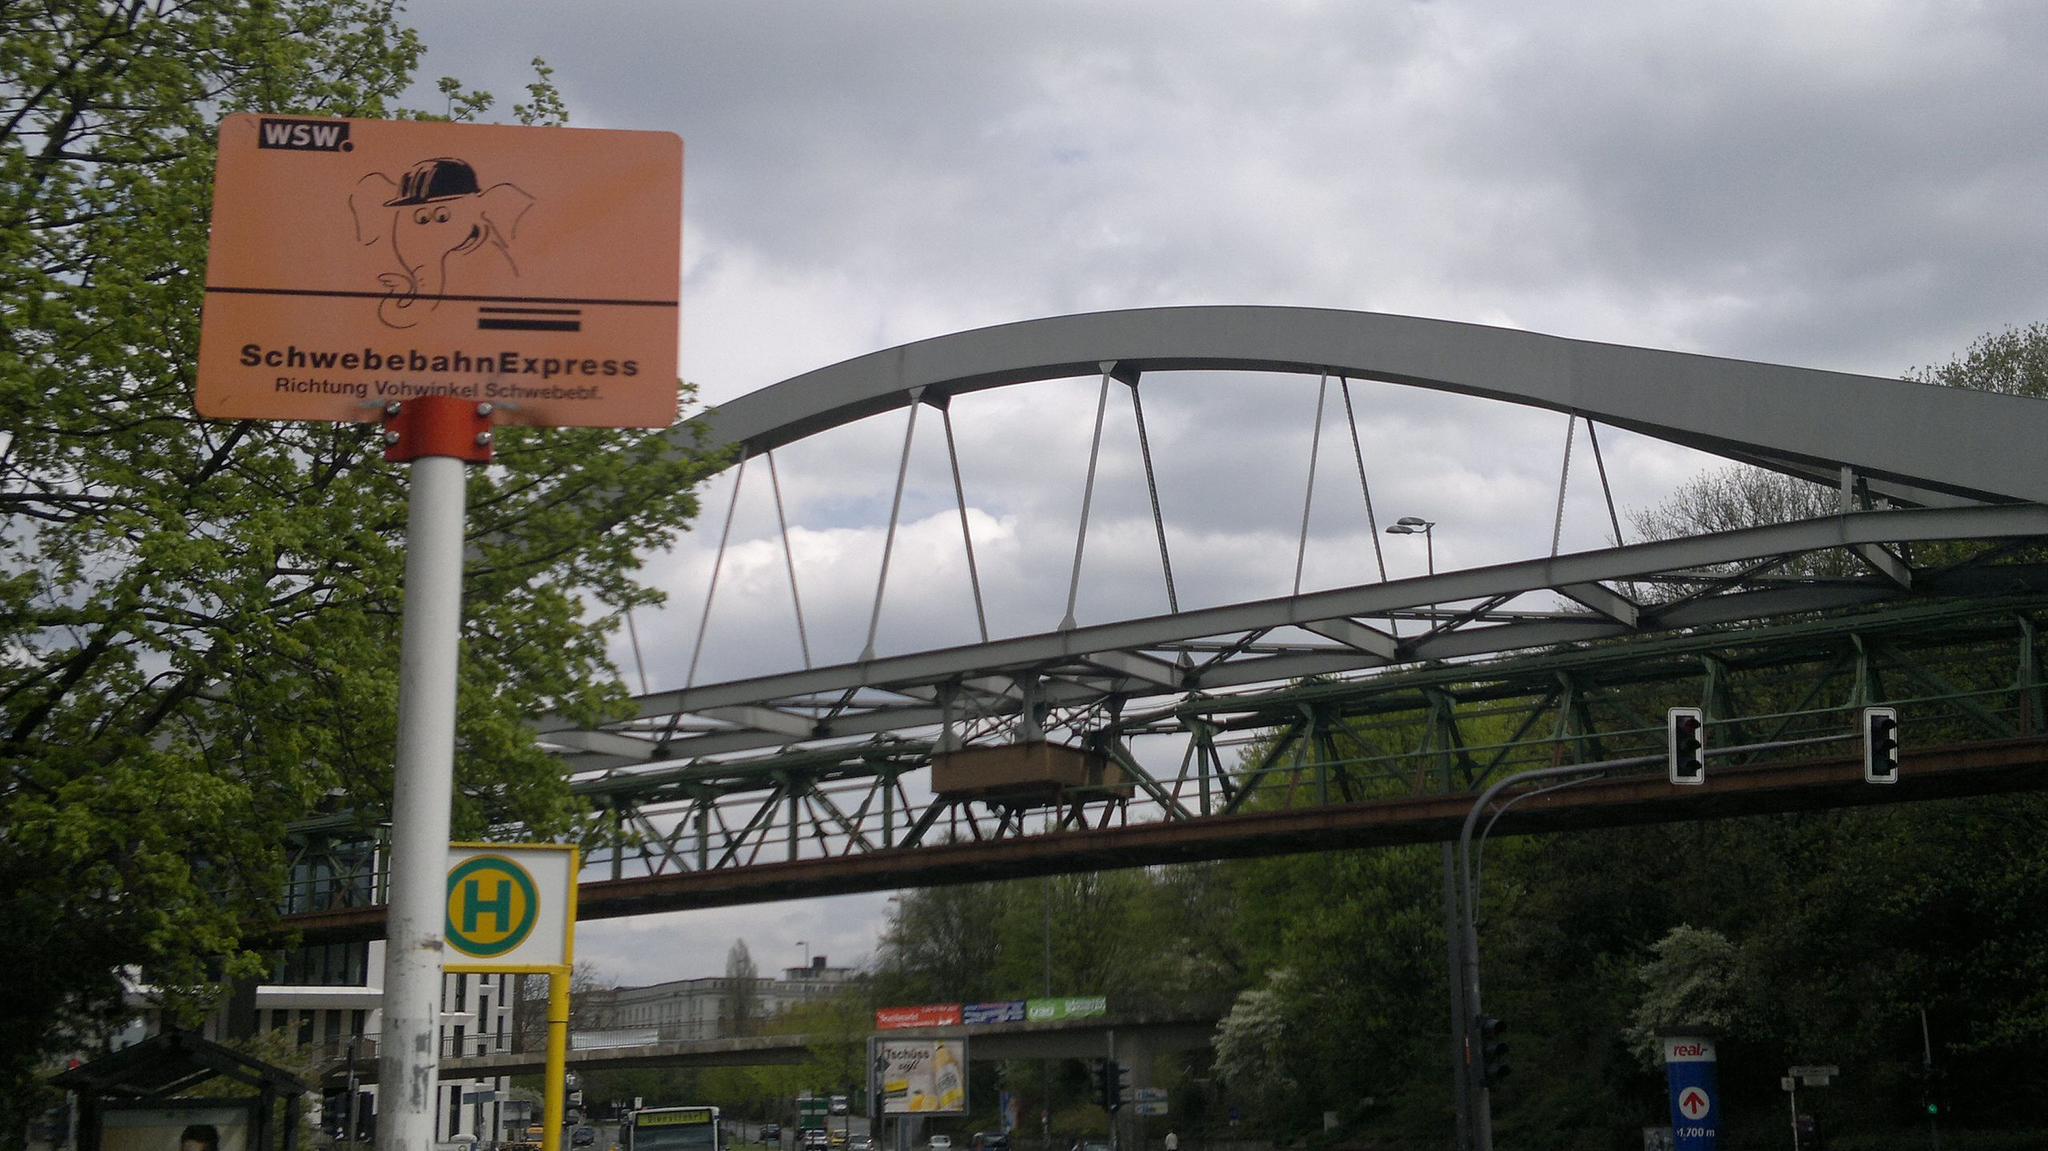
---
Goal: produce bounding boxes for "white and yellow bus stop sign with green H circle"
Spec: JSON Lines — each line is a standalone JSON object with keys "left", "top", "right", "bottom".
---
{"left": 442, "top": 844, "right": 578, "bottom": 973}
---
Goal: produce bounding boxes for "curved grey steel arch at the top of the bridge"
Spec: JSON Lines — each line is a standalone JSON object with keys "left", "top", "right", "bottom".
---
{"left": 692, "top": 307, "right": 2048, "bottom": 504}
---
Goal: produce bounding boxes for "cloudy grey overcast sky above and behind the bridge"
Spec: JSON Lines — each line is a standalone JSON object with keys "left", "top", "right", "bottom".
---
{"left": 391, "top": 0, "right": 2048, "bottom": 991}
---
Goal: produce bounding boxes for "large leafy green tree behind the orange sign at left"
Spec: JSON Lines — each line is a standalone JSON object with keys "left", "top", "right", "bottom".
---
{"left": 0, "top": 0, "right": 711, "bottom": 1133}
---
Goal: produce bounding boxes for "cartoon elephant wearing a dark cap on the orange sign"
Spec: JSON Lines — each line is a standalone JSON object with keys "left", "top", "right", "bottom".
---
{"left": 348, "top": 158, "right": 532, "bottom": 328}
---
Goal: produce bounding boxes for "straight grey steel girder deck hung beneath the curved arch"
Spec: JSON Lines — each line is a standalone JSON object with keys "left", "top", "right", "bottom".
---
{"left": 539, "top": 504, "right": 2048, "bottom": 772}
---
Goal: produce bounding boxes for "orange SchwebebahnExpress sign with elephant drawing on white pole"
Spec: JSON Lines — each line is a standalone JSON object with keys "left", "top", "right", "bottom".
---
{"left": 197, "top": 113, "right": 682, "bottom": 428}
